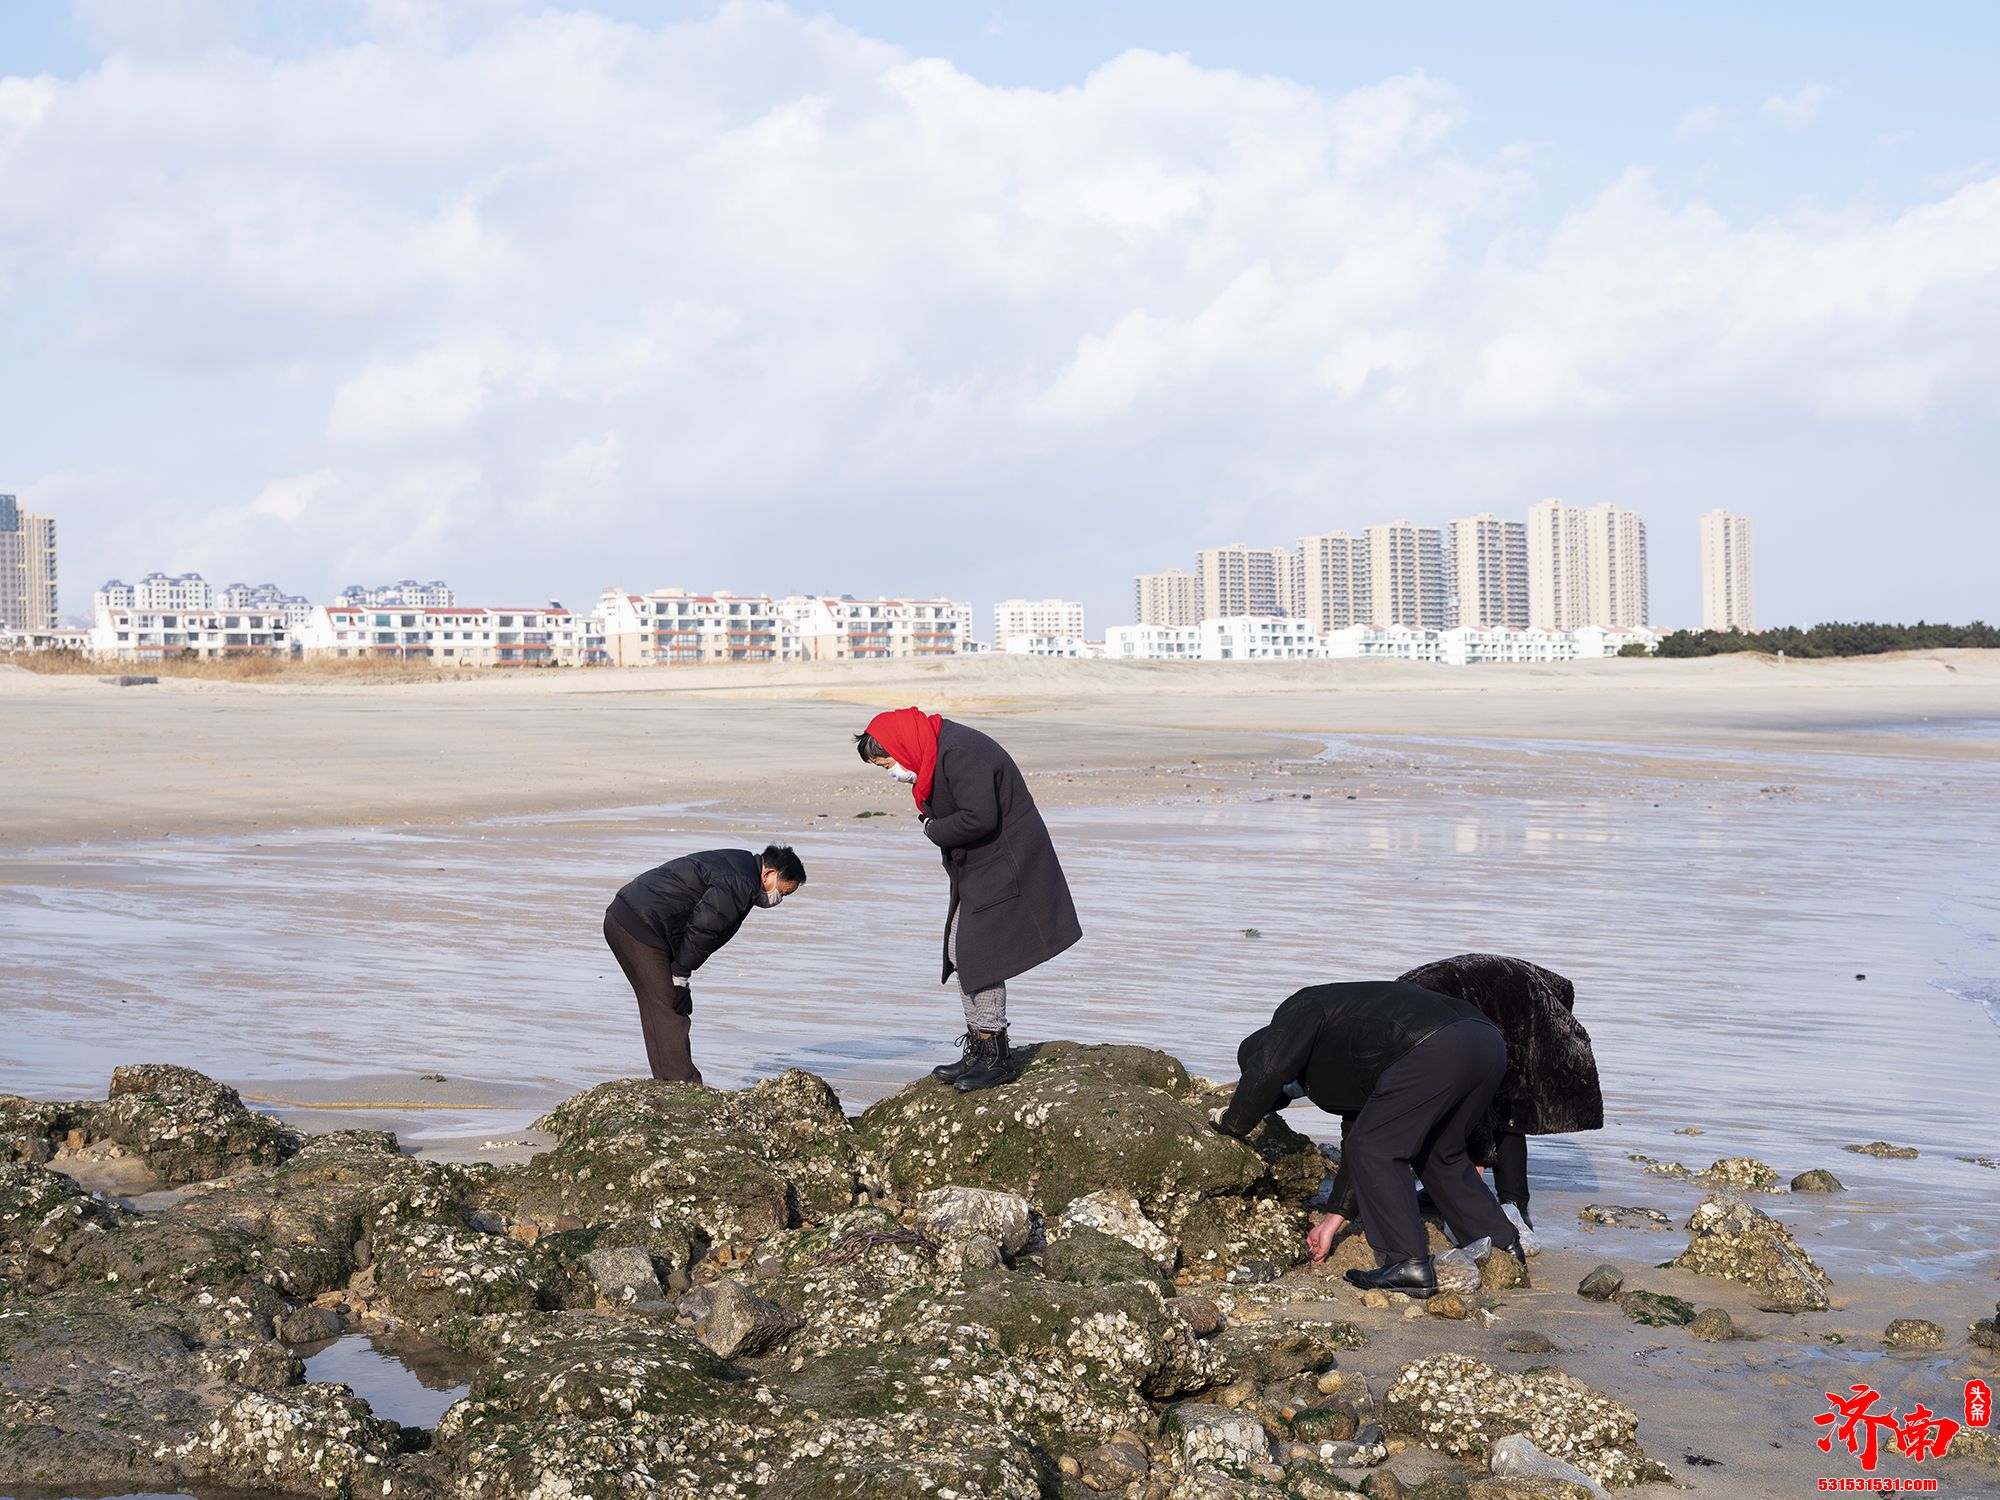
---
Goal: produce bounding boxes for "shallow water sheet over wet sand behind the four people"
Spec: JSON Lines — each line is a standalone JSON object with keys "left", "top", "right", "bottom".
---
{"left": 0, "top": 742, "right": 2000, "bottom": 1276}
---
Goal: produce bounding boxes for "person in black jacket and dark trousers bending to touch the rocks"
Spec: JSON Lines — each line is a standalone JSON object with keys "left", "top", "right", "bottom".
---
{"left": 1210, "top": 980, "right": 1520, "bottom": 1296}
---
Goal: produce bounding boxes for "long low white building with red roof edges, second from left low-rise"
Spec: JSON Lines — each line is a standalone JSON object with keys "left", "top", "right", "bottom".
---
{"left": 300, "top": 604, "right": 606, "bottom": 668}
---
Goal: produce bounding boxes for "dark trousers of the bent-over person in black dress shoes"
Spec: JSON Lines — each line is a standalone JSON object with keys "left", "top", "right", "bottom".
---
{"left": 1340, "top": 1020, "right": 1516, "bottom": 1262}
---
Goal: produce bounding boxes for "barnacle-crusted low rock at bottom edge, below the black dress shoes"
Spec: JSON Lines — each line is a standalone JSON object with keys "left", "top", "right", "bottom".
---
{"left": 1382, "top": 1354, "right": 1666, "bottom": 1484}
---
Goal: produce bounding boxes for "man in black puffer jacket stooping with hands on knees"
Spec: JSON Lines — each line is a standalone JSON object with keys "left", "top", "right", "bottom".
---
{"left": 604, "top": 844, "right": 806, "bottom": 1084}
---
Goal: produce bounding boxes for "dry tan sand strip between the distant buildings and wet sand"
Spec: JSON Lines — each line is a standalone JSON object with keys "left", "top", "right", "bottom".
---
{"left": 0, "top": 652, "right": 2000, "bottom": 854}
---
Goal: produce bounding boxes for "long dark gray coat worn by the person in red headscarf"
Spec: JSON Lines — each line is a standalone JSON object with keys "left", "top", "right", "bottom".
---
{"left": 924, "top": 720, "right": 1084, "bottom": 990}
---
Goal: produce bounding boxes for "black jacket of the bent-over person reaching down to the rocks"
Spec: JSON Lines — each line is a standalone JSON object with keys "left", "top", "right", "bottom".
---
{"left": 1222, "top": 980, "right": 1492, "bottom": 1136}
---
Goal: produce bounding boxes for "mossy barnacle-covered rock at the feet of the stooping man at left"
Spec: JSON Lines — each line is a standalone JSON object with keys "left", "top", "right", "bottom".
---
{"left": 490, "top": 1068, "right": 856, "bottom": 1244}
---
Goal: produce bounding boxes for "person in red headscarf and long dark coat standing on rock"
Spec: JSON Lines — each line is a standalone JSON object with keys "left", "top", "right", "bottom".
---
{"left": 854, "top": 708, "right": 1084, "bottom": 1092}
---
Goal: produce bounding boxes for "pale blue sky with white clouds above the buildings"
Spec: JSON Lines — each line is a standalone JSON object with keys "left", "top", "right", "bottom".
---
{"left": 0, "top": 0, "right": 2000, "bottom": 634}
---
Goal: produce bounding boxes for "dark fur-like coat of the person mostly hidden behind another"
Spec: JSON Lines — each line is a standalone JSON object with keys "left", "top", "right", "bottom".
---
{"left": 1402, "top": 954, "right": 1604, "bottom": 1154}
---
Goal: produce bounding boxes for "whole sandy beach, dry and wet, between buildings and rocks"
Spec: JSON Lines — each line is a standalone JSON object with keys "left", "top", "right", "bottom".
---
{"left": 0, "top": 652, "right": 2000, "bottom": 1494}
